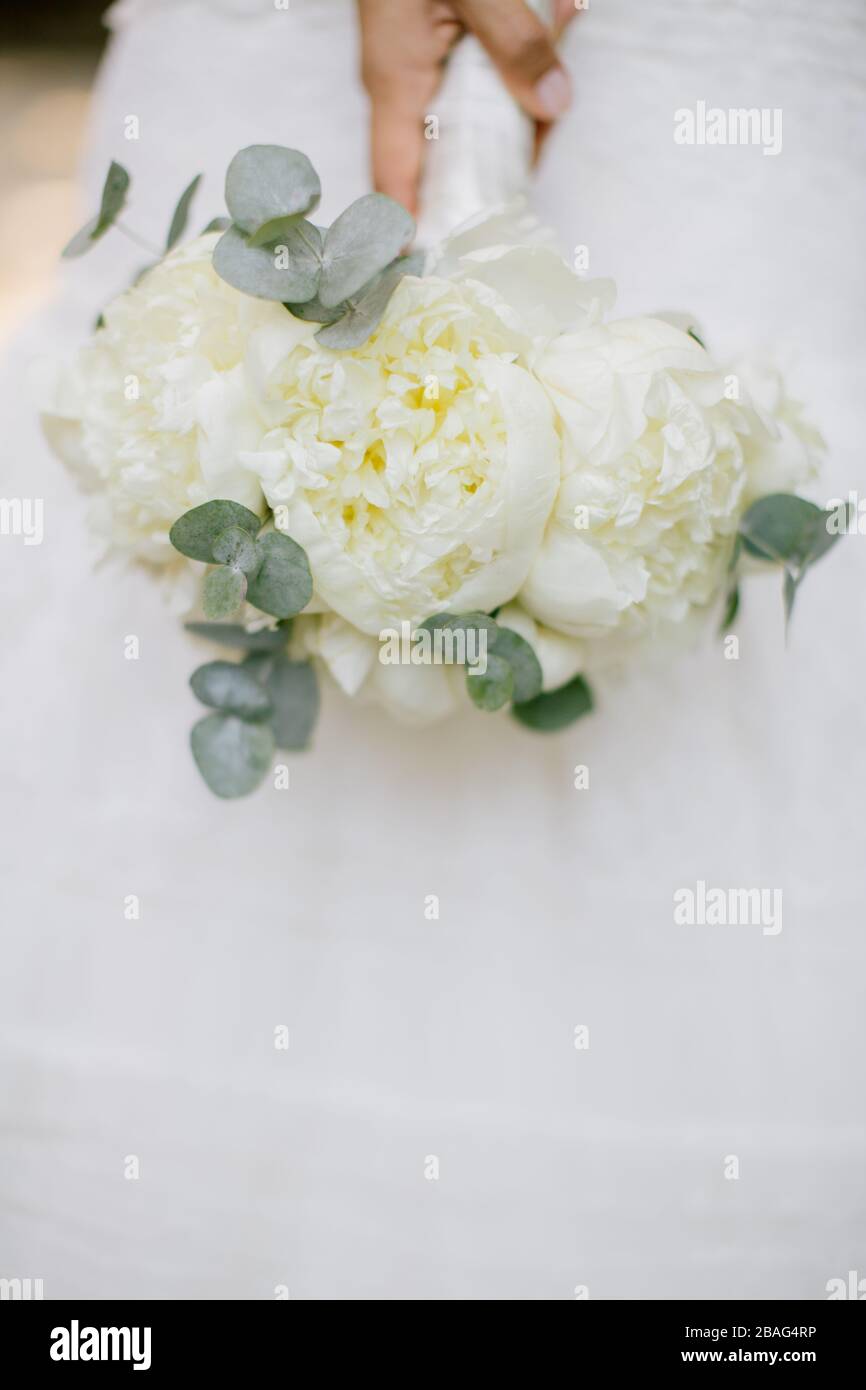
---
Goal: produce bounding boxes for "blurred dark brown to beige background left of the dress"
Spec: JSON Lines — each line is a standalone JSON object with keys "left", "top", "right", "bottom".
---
{"left": 0, "top": 0, "right": 107, "bottom": 349}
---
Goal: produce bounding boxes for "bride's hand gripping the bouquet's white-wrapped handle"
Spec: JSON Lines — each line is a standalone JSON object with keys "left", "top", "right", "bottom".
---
{"left": 359, "top": 0, "right": 575, "bottom": 213}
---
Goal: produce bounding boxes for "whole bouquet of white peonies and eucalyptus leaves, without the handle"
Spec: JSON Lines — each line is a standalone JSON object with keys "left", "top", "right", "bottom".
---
{"left": 44, "top": 146, "right": 844, "bottom": 796}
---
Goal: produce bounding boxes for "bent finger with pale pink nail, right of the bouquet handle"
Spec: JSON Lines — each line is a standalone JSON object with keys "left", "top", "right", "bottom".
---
{"left": 456, "top": 0, "right": 571, "bottom": 121}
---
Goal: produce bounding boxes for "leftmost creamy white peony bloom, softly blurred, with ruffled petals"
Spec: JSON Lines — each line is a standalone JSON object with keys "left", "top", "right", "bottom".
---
{"left": 39, "top": 235, "right": 291, "bottom": 566}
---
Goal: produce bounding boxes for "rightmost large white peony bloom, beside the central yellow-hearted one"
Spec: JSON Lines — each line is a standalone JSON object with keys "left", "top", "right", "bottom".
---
{"left": 520, "top": 318, "right": 811, "bottom": 638}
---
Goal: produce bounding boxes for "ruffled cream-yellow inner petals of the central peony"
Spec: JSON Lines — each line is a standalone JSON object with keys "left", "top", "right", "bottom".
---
{"left": 264, "top": 281, "right": 506, "bottom": 602}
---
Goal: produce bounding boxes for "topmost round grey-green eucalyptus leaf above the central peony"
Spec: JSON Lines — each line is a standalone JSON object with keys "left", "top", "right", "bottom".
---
{"left": 225, "top": 145, "right": 321, "bottom": 236}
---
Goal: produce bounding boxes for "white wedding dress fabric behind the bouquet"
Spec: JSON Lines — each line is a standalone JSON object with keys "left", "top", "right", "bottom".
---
{"left": 0, "top": 0, "right": 866, "bottom": 1300}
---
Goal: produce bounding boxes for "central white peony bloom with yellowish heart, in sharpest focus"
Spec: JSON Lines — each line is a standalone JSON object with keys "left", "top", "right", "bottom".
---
{"left": 243, "top": 269, "right": 559, "bottom": 635}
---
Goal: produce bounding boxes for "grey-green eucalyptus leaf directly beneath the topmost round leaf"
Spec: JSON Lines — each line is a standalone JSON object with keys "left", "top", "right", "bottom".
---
{"left": 214, "top": 218, "right": 321, "bottom": 303}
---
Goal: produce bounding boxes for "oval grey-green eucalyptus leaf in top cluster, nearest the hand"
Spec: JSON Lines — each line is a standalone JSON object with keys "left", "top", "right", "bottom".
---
{"left": 318, "top": 193, "right": 416, "bottom": 306}
